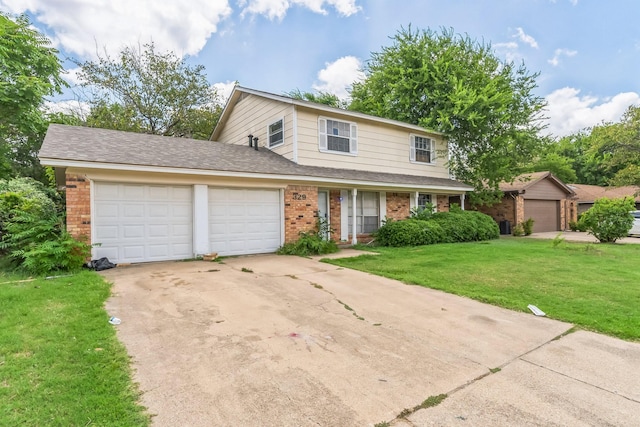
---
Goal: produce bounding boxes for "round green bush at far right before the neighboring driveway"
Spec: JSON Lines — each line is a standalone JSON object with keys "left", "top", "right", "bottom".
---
{"left": 580, "top": 197, "right": 635, "bottom": 243}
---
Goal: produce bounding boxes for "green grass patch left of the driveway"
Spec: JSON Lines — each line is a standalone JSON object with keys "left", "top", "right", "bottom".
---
{"left": 0, "top": 272, "right": 149, "bottom": 426}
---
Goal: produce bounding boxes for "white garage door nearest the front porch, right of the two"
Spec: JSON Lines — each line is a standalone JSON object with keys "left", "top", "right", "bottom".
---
{"left": 209, "top": 188, "right": 282, "bottom": 255}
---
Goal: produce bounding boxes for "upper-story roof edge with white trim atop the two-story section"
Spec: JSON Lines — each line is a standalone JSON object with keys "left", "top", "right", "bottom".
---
{"left": 209, "top": 85, "right": 444, "bottom": 141}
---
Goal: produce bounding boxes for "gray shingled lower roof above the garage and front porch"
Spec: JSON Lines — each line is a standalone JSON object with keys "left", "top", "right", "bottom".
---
{"left": 39, "top": 124, "right": 470, "bottom": 191}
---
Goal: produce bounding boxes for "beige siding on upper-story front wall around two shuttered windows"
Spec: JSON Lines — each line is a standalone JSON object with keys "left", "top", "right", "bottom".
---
{"left": 297, "top": 108, "right": 449, "bottom": 178}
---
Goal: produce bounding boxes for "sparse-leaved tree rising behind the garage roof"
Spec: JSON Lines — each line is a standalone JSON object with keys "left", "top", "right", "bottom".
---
{"left": 78, "top": 43, "right": 221, "bottom": 139}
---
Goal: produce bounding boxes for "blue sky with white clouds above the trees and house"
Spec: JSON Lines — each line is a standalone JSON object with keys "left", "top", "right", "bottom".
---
{"left": 0, "top": 0, "right": 640, "bottom": 136}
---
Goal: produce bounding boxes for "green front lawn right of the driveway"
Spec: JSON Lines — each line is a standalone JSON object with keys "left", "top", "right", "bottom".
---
{"left": 325, "top": 238, "right": 640, "bottom": 340}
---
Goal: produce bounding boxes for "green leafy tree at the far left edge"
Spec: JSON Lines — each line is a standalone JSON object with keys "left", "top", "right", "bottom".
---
{"left": 0, "top": 13, "right": 66, "bottom": 180}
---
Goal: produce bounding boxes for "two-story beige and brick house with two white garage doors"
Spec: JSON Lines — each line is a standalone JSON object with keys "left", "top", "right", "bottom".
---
{"left": 39, "top": 86, "right": 472, "bottom": 263}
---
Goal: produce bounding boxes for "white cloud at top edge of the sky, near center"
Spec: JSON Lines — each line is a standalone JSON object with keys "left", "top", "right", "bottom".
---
{"left": 238, "top": 0, "right": 361, "bottom": 20}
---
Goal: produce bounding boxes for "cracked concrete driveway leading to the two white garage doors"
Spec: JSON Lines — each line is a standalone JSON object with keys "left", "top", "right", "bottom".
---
{"left": 104, "top": 255, "right": 640, "bottom": 426}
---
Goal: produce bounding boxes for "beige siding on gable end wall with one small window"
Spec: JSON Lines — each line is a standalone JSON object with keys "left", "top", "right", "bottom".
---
{"left": 218, "top": 95, "right": 293, "bottom": 160}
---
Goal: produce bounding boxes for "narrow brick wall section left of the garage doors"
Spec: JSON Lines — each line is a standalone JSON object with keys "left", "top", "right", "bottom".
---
{"left": 66, "top": 174, "right": 91, "bottom": 243}
